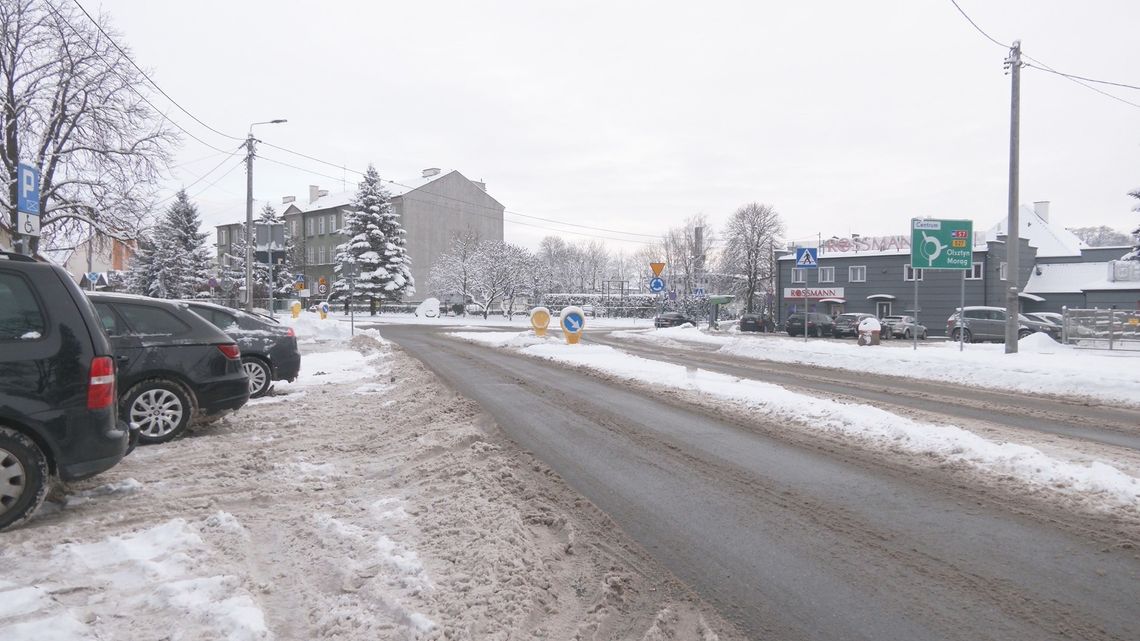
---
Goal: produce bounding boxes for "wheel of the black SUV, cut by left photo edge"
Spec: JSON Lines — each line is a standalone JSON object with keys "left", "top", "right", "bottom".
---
{"left": 0, "top": 428, "right": 50, "bottom": 529}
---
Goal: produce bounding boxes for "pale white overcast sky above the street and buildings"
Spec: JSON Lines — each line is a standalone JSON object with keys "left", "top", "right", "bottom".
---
{"left": 93, "top": 0, "right": 1140, "bottom": 250}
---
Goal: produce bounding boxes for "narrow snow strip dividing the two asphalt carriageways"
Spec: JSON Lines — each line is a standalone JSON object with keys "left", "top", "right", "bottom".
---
{"left": 463, "top": 333, "right": 1140, "bottom": 506}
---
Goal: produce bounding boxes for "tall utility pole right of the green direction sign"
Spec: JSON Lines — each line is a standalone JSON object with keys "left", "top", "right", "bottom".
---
{"left": 1005, "top": 40, "right": 1021, "bottom": 354}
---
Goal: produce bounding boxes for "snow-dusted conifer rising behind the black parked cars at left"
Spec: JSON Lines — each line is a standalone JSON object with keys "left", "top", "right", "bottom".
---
{"left": 128, "top": 189, "right": 210, "bottom": 299}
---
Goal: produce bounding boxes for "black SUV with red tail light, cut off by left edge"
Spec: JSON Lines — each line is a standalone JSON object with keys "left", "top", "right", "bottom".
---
{"left": 0, "top": 252, "right": 130, "bottom": 529}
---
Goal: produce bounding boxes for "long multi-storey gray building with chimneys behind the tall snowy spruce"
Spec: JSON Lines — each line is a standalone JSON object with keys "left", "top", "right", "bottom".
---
{"left": 217, "top": 168, "right": 505, "bottom": 299}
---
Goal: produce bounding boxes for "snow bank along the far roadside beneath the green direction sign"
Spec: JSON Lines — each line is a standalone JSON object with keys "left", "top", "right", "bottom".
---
{"left": 611, "top": 327, "right": 1140, "bottom": 406}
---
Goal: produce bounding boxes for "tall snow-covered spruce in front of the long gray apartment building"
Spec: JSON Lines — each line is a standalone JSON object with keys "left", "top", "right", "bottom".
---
{"left": 333, "top": 164, "right": 416, "bottom": 300}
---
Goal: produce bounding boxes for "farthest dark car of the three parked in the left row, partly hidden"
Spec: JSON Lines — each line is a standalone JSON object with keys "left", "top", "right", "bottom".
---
{"left": 186, "top": 300, "right": 301, "bottom": 398}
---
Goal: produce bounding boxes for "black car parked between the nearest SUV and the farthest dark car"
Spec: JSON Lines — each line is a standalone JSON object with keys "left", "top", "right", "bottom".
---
{"left": 88, "top": 292, "right": 250, "bottom": 444}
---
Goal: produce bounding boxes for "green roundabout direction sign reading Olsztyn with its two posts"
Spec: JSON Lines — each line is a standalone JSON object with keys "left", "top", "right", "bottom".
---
{"left": 911, "top": 218, "right": 974, "bottom": 351}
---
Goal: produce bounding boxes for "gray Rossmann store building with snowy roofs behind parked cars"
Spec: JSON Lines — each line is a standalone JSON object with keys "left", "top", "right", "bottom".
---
{"left": 776, "top": 202, "right": 1140, "bottom": 335}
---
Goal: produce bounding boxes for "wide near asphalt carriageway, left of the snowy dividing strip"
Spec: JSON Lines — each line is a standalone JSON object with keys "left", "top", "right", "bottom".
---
{"left": 383, "top": 325, "right": 1140, "bottom": 641}
